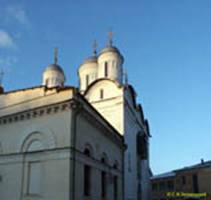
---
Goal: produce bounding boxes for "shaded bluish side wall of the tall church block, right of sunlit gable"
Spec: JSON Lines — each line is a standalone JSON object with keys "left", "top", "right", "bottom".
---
{"left": 124, "top": 88, "right": 150, "bottom": 200}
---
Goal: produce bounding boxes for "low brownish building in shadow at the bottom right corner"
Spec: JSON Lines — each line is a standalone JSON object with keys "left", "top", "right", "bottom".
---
{"left": 151, "top": 160, "right": 211, "bottom": 200}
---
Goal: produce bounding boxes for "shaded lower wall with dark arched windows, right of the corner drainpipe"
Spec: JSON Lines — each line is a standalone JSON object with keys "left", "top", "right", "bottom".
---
{"left": 76, "top": 112, "right": 123, "bottom": 200}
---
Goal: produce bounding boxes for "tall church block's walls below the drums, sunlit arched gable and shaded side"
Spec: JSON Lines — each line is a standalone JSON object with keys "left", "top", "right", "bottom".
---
{"left": 86, "top": 80, "right": 149, "bottom": 200}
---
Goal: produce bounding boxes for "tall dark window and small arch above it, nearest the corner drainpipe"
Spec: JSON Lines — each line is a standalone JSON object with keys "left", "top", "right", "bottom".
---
{"left": 84, "top": 148, "right": 91, "bottom": 196}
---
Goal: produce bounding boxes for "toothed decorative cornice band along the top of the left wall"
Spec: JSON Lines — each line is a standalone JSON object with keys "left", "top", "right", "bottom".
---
{"left": 0, "top": 99, "right": 78, "bottom": 125}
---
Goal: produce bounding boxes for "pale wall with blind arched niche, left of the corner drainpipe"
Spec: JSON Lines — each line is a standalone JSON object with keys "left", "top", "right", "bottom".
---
{"left": 0, "top": 108, "right": 71, "bottom": 200}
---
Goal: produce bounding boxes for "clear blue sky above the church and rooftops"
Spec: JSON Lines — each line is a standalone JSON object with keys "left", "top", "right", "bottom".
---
{"left": 0, "top": 0, "right": 211, "bottom": 173}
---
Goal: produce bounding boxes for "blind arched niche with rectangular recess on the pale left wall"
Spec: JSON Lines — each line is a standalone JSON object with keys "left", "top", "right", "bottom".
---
{"left": 19, "top": 130, "right": 56, "bottom": 196}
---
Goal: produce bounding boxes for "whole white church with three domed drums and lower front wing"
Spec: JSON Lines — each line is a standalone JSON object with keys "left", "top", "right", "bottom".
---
{"left": 0, "top": 35, "right": 150, "bottom": 200}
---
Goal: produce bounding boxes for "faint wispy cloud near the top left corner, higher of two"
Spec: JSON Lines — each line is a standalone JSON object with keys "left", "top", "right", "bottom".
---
{"left": 6, "top": 5, "right": 30, "bottom": 26}
